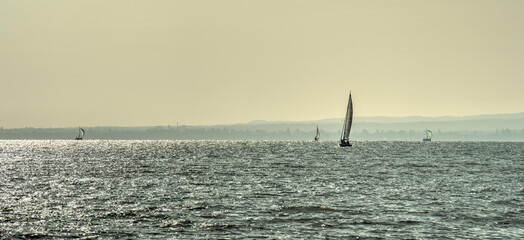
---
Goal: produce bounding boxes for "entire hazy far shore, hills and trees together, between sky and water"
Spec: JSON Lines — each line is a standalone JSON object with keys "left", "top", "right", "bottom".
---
{"left": 0, "top": 113, "right": 524, "bottom": 141}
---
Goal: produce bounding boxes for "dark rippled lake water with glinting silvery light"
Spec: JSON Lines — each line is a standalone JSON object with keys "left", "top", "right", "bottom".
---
{"left": 0, "top": 141, "right": 524, "bottom": 239}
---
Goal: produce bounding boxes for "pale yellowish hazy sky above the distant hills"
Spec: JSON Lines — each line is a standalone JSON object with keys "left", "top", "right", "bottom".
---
{"left": 0, "top": 0, "right": 524, "bottom": 128}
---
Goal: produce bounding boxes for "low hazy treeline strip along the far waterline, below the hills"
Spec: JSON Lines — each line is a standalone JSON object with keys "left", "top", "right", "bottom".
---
{"left": 0, "top": 126, "right": 524, "bottom": 141}
